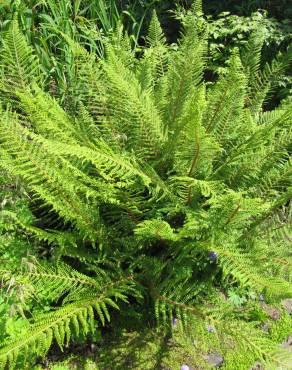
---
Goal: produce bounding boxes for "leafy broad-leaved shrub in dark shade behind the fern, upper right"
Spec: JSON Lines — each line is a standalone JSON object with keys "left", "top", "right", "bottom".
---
{"left": 209, "top": 11, "right": 292, "bottom": 101}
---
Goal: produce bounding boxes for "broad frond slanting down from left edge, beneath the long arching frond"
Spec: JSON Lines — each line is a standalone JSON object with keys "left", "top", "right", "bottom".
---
{"left": 1, "top": 113, "right": 98, "bottom": 235}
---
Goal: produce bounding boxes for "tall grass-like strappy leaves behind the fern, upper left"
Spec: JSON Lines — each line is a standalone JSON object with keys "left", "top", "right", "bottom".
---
{"left": 0, "top": 0, "right": 143, "bottom": 101}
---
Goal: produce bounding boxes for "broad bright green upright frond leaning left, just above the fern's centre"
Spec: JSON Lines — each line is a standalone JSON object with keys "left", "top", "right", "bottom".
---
{"left": 103, "top": 45, "right": 165, "bottom": 159}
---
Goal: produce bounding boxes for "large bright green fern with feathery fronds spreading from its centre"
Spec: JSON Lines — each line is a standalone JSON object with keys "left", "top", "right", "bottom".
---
{"left": 0, "top": 1, "right": 292, "bottom": 369}
